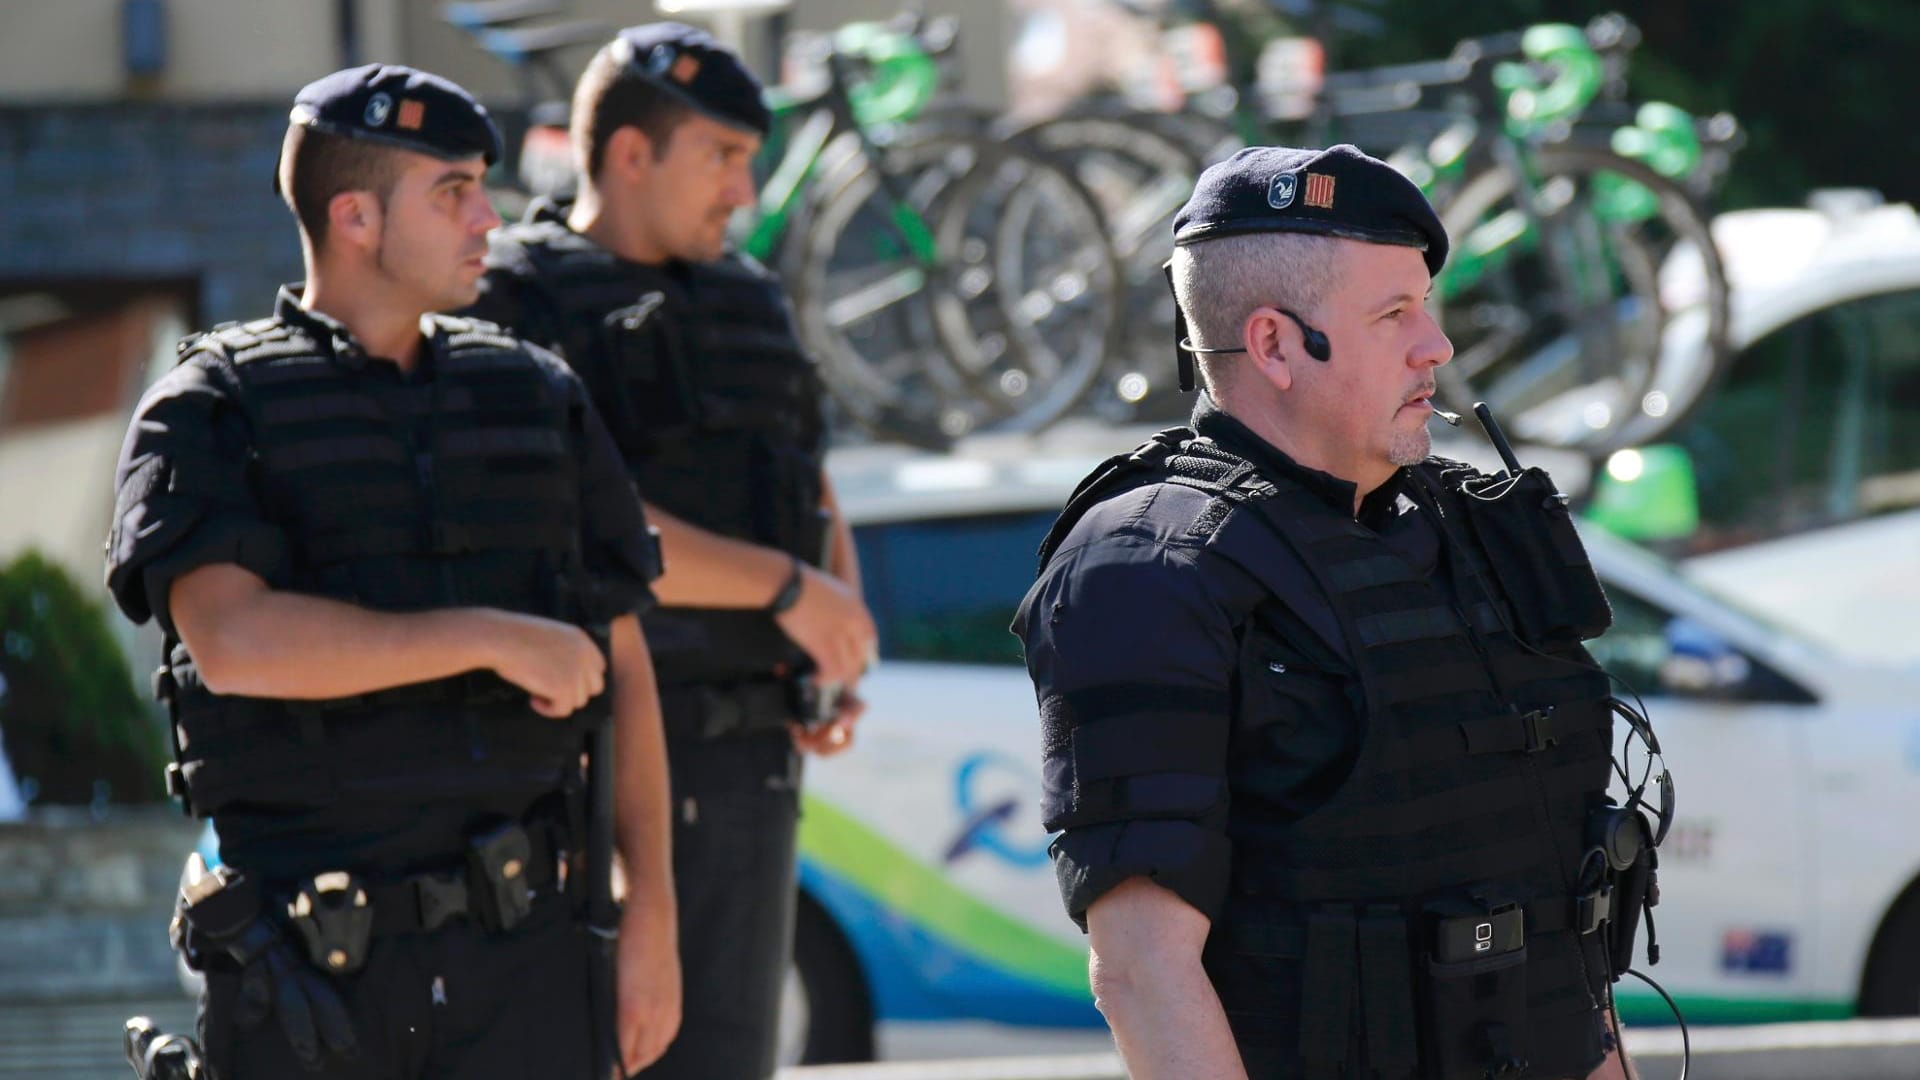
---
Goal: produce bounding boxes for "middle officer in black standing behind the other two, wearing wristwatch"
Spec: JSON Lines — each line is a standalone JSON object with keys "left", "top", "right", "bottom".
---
{"left": 472, "top": 23, "right": 874, "bottom": 1080}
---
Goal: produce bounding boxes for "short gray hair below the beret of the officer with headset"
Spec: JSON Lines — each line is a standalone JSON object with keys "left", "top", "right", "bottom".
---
{"left": 1173, "top": 233, "right": 1340, "bottom": 390}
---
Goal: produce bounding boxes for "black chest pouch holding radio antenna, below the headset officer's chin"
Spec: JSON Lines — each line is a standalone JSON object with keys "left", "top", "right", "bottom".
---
{"left": 1459, "top": 469, "right": 1613, "bottom": 648}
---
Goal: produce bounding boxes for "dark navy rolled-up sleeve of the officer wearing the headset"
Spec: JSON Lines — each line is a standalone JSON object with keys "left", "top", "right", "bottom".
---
{"left": 1016, "top": 534, "right": 1238, "bottom": 928}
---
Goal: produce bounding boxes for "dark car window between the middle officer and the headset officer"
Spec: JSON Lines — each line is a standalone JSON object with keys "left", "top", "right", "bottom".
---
{"left": 854, "top": 511, "right": 1056, "bottom": 665}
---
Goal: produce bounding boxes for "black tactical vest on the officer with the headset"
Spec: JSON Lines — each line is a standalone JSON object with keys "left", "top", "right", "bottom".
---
{"left": 1043, "top": 429, "right": 1611, "bottom": 1080}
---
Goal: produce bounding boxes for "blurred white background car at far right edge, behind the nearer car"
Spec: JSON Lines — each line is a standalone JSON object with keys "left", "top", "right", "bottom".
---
{"left": 1592, "top": 190, "right": 1920, "bottom": 665}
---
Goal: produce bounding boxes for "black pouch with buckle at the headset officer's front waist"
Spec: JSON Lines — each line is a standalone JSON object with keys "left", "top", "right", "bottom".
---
{"left": 1419, "top": 903, "right": 1526, "bottom": 1080}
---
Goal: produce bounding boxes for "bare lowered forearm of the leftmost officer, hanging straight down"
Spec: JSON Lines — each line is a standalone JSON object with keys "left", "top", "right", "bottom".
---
{"left": 612, "top": 615, "right": 674, "bottom": 922}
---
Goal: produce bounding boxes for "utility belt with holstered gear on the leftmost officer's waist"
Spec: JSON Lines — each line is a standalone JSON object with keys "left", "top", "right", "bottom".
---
{"left": 171, "top": 817, "right": 566, "bottom": 974}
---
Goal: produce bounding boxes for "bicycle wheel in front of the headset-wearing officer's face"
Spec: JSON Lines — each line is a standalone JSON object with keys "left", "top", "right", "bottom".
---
{"left": 1436, "top": 146, "right": 1730, "bottom": 455}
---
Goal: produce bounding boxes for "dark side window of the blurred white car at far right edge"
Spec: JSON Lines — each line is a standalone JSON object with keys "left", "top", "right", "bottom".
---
{"left": 1680, "top": 292, "right": 1920, "bottom": 553}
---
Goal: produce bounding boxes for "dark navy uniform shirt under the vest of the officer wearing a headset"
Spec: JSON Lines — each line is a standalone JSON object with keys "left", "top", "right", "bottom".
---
{"left": 1014, "top": 396, "right": 1444, "bottom": 926}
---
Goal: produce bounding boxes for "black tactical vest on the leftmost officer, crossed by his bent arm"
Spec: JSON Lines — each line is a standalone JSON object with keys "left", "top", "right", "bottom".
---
{"left": 161, "top": 315, "right": 607, "bottom": 815}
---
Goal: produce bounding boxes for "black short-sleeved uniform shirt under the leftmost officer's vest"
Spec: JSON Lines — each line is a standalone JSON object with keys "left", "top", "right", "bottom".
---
{"left": 108, "top": 286, "right": 659, "bottom": 872}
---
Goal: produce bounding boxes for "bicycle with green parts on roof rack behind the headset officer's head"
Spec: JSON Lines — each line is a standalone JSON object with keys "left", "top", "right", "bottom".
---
{"left": 1043, "top": 0, "right": 1740, "bottom": 455}
